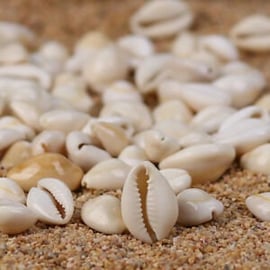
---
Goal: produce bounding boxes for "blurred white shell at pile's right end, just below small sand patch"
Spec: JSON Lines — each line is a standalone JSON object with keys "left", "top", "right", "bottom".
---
{"left": 213, "top": 70, "right": 266, "bottom": 108}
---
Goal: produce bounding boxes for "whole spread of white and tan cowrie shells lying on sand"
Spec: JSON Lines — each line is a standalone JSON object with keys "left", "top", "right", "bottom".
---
{"left": 0, "top": 0, "right": 270, "bottom": 243}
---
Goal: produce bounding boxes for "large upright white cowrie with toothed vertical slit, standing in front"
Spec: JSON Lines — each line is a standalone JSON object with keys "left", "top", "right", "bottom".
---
{"left": 121, "top": 161, "right": 178, "bottom": 243}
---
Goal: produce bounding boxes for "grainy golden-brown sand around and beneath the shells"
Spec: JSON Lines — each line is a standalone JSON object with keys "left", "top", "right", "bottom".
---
{"left": 0, "top": 0, "right": 270, "bottom": 270}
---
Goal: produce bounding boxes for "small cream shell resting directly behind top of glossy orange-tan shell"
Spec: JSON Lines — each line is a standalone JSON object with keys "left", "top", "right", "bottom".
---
{"left": 32, "top": 130, "right": 66, "bottom": 156}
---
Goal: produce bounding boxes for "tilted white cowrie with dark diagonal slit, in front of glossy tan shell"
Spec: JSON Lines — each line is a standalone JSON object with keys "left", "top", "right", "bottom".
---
{"left": 26, "top": 178, "right": 74, "bottom": 225}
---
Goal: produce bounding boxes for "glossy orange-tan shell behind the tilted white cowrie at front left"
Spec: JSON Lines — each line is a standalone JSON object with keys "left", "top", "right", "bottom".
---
{"left": 7, "top": 153, "right": 83, "bottom": 191}
